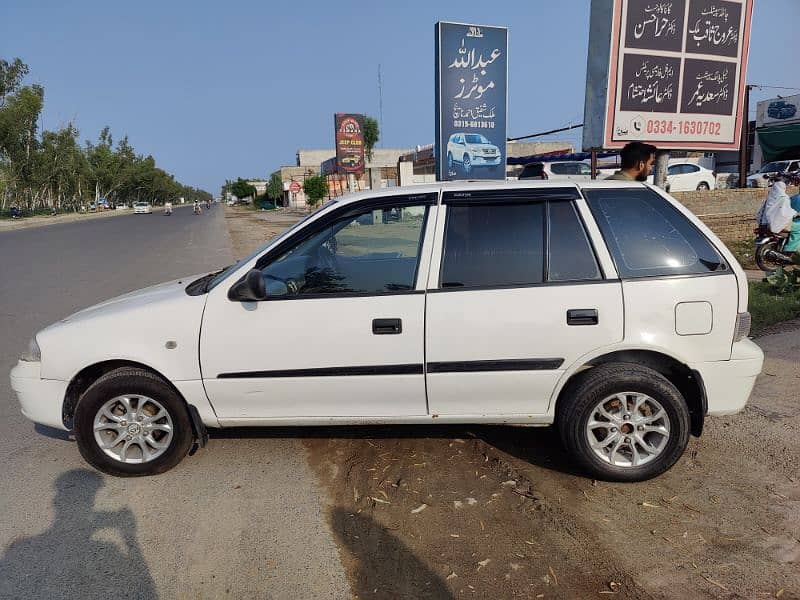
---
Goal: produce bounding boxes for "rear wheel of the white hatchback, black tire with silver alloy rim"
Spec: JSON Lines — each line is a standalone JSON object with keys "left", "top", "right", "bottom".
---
{"left": 556, "top": 363, "right": 691, "bottom": 481}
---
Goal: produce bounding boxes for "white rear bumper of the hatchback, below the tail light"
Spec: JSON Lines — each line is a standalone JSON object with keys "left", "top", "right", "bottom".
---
{"left": 690, "top": 339, "right": 764, "bottom": 416}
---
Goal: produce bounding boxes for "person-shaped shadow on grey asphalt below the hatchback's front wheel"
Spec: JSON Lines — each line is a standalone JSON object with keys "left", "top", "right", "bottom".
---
{"left": 0, "top": 469, "right": 157, "bottom": 599}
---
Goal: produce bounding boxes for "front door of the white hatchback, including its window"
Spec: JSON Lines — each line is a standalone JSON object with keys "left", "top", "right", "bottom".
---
{"left": 200, "top": 193, "right": 437, "bottom": 425}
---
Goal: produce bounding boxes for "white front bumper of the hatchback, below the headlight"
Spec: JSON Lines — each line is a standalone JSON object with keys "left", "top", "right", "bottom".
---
{"left": 11, "top": 360, "right": 67, "bottom": 430}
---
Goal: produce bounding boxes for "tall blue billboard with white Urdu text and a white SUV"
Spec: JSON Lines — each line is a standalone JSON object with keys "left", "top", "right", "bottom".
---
{"left": 435, "top": 22, "right": 508, "bottom": 181}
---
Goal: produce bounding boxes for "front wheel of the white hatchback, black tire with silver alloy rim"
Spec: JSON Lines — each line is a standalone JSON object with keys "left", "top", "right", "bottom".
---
{"left": 74, "top": 367, "right": 194, "bottom": 477}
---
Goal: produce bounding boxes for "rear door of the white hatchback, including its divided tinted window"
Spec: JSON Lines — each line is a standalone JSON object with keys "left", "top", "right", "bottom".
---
{"left": 426, "top": 187, "right": 623, "bottom": 416}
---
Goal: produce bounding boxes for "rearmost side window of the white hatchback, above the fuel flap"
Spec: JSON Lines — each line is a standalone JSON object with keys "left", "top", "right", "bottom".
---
{"left": 584, "top": 189, "right": 726, "bottom": 278}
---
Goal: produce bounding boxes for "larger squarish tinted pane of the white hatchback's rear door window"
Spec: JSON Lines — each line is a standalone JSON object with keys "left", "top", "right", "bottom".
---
{"left": 441, "top": 202, "right": 544, "bottom": 288}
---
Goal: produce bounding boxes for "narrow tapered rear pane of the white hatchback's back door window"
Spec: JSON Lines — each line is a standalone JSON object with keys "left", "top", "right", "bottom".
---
{"left": 548, "top": 202, "right": 601, "bottom": 281}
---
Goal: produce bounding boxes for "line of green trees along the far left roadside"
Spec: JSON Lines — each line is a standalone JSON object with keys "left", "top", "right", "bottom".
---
{"left": 0, "top": 58, "right": 212, "bottom": 211}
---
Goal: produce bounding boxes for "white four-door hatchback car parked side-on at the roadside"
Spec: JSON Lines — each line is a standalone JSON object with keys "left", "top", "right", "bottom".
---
{"left": 11, "top": 181, "right": 763, "bottom": 481}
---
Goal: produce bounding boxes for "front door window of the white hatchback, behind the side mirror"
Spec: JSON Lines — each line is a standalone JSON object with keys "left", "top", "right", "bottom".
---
{"left": 263, "top": 205, "right": 427, "bottom": 296}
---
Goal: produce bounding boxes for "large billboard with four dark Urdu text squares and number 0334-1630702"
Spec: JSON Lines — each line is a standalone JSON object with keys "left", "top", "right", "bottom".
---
{"left": 583, "top": 0, "right": 753, "bottom": 150}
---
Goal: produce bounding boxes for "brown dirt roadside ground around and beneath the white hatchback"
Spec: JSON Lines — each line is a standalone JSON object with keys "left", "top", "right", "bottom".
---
{"left": 226, "top": 209, "right": 800, "bottom": 599}
